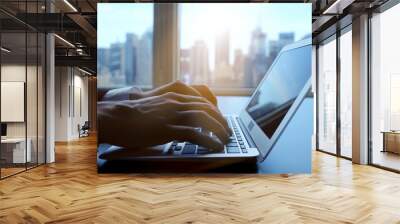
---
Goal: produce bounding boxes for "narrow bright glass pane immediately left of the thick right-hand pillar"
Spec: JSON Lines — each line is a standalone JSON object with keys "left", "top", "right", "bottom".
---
{"left": 340, "top": 30, "right": 353, "bottom": 158}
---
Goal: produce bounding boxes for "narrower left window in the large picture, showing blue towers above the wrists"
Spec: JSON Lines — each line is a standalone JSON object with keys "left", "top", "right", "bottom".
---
{"left": 97, "top": 3, "right": 154, "bottom": 88}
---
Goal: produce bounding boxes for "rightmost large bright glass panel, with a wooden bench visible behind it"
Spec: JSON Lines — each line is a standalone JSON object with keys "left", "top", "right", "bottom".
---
{"left": 371, "top": 4, "right": 400, "bottom": 170}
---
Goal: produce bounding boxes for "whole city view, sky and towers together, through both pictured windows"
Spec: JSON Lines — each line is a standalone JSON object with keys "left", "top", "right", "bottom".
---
{"left": 98, "top": 3, "right": 311, "bottom": 88}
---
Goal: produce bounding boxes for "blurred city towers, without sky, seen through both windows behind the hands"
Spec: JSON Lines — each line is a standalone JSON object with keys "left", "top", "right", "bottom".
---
{"left": 98, "top": 27, "right": 295, "bottom": 87}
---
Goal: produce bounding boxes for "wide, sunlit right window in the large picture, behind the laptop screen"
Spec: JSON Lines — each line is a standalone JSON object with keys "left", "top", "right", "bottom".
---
{"left": 178, "top": 3, "right": 311, "bottom": 92}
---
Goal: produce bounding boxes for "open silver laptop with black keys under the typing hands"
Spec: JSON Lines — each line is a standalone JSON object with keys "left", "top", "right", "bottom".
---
{"left": 99, "top": 39, "right": 312, "bottom": 162}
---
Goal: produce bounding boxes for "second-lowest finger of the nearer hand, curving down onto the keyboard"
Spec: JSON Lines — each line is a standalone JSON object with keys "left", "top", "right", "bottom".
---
{"left": 174, "top": 111, "right": 229, "bottom": 143}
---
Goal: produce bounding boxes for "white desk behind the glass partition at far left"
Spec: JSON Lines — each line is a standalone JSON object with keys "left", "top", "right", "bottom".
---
{"left": 1, "top": 138, "right": 32, "bottom": 164}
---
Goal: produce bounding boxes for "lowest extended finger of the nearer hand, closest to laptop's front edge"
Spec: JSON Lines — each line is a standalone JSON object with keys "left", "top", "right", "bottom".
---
{"left": 168, "top": 125, "right": 224, "bottom": 151}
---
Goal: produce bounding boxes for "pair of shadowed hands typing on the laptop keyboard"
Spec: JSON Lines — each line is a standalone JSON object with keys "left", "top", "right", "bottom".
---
{"left": 98, "top": 81, "right": 231, "bottom": 150}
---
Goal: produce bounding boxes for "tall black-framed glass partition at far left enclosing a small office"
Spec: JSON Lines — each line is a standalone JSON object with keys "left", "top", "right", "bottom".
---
{"left": 0, "top": 1, "right": 46, "bottom": 178}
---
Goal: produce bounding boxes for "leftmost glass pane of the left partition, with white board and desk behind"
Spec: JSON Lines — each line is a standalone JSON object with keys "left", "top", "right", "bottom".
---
{"left": 1, "top": 31, "right": 30, "bottom": 177}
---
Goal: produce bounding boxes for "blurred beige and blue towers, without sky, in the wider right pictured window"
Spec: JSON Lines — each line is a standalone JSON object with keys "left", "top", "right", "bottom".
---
{"left": 179, "top": 27, "right": 295, "bottom": 87}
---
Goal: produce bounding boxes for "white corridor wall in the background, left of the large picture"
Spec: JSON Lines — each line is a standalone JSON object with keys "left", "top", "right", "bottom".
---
{"left": 55, "top": 67, "right": 89, "bottom": 141}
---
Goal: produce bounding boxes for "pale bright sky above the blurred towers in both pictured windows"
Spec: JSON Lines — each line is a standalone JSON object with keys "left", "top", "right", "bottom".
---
{"left": 97, "top": 3, "right": 311, "bottom": 49}
